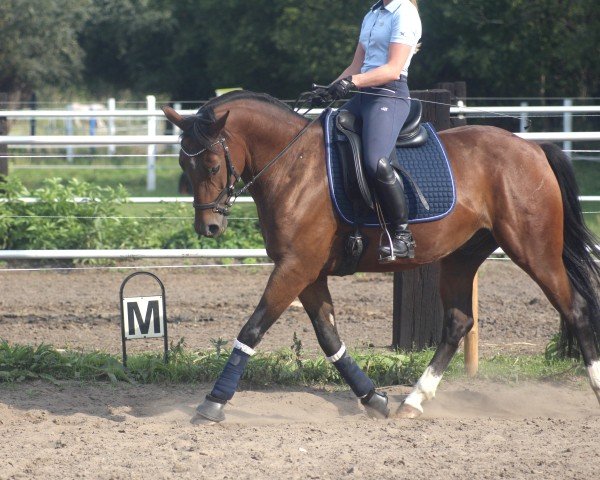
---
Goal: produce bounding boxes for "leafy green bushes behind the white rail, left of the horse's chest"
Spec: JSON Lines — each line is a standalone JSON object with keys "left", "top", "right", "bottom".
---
{"left": 0, "top": 176, "right": 263, "bottom": 250}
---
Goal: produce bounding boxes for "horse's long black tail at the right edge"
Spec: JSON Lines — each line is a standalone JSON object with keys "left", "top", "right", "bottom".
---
{"left": 540, "top": 143, "right": 600, "bottom": 355}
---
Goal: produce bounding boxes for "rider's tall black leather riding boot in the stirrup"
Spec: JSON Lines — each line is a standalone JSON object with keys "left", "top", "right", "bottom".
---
{"left": 375, "top": 158, "right": 415, "bottom": 263}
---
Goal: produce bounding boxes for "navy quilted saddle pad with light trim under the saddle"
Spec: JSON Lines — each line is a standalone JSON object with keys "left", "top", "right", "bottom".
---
{"left": 323, "top": 110, "right": 456, "bottom": 227}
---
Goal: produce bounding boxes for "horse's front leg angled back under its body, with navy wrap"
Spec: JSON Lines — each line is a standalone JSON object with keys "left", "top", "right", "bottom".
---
{"left": 299, "top": 277, "right": 389, "bottom": 417}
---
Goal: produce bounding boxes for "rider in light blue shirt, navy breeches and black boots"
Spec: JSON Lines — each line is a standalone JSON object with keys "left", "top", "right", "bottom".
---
{"left": 317, "top": 0, "right": 421, "bottom": 261}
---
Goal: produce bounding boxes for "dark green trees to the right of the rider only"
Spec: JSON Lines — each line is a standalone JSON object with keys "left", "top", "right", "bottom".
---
{"left": 412, "top": 0, "right": 600, "bottom": 97}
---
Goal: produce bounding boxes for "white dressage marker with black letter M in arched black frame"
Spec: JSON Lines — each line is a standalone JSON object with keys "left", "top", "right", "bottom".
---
{"left": 119, "top": 272, "right": 169, "bottom": 367}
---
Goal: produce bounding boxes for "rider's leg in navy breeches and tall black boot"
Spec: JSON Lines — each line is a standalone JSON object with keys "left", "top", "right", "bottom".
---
{"left": 361, "top": 81, "right": 414, "bottom": 261}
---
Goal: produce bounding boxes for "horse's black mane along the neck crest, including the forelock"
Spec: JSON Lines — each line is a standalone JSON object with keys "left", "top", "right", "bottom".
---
{"left": 182, "top": 90, "right": 303, "bottom": 148}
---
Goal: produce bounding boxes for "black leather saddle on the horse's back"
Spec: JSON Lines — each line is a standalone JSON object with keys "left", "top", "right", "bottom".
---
{"left": 335, "top": 99, "right": 429, "bottom": 212}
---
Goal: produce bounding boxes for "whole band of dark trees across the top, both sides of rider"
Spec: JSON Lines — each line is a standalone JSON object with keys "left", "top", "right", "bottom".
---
{"left": 0, "top": 0, "right": 600, "bottom": 100}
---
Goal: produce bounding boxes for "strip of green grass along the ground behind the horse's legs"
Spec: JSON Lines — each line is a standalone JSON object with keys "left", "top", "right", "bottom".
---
{"left": 0, "top": 341, "right": 585, "bottom": 386}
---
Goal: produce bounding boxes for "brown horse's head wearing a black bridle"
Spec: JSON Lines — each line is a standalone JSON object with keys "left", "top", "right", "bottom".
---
{"left": 162, "top": 106, "right": 239, "bottom": 237}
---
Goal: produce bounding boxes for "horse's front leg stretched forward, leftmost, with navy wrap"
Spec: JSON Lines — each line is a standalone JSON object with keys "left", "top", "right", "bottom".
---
{"left": 192, "top": 262, "right": 313, "bottom": 423}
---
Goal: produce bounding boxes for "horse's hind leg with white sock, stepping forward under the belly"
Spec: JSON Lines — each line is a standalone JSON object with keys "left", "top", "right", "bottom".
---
{"left": 395, "top": 238, "right": 495, "bottom": 418}
